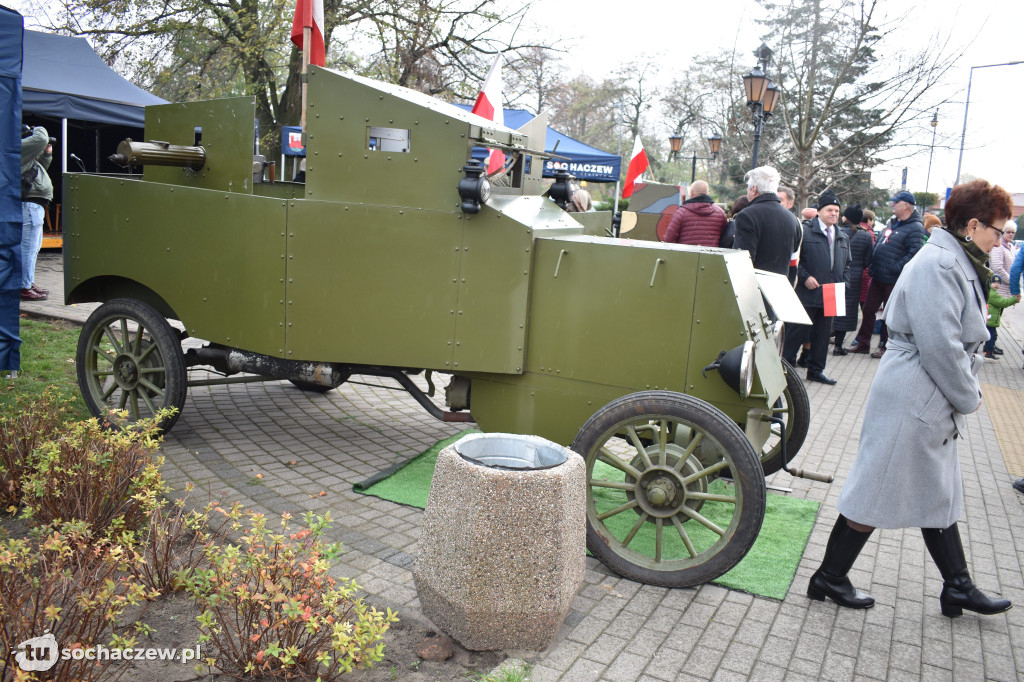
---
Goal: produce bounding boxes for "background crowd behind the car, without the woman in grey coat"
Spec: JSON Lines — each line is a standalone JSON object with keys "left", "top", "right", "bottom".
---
{"left": 665, "top": 166, "right": 1024, "bottom": 382}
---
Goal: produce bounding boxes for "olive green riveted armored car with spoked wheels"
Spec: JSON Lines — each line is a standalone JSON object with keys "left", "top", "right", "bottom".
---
{"left": 63, "top": 67, "right": 808, "bottom": 586}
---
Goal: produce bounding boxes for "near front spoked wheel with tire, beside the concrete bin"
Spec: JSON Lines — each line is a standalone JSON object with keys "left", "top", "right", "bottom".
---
{"left": 572, "top": 391, "right": 765, "bottom": 587}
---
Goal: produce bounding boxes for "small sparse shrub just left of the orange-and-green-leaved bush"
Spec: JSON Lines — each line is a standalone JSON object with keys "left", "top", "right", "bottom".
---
{"left": 131, "top": 483, "right": 231, "bottom": 594}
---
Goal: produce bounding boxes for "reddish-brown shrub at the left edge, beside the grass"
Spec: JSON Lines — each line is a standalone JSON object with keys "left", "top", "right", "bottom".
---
{"left": 0, "top": 389, "right": 68, "bottom": 511}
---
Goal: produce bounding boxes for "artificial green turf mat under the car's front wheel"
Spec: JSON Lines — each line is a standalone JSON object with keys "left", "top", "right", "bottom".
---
{"left": 353, "top": 429, "right": 819, "bottom": 599}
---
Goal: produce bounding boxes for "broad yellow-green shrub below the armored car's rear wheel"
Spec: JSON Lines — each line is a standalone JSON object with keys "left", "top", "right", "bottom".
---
{"left": 22, "top": 417, "right": 166, "bottom": 541}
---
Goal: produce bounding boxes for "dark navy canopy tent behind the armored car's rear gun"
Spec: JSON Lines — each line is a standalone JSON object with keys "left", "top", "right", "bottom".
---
{"left": 22, "top": 31, "right": 166, "bottom": 235}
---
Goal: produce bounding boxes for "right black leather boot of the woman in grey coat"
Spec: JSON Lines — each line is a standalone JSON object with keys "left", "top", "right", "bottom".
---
{"left": 921, "top": 523, "right": 1013, "bottom": 619}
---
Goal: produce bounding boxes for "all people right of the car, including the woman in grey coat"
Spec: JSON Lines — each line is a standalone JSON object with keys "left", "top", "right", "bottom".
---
{"left": 667, "top": 166, "right": 1024, "bottom": 617}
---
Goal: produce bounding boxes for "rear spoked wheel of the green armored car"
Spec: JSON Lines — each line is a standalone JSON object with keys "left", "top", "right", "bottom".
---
{"left": 77, "top": 299, "right": 186, "bottom": 431}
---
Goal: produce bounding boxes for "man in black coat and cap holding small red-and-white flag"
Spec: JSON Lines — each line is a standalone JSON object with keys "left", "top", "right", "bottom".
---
{"left": 782, "top": 189, "right": 850, "bottom": 385}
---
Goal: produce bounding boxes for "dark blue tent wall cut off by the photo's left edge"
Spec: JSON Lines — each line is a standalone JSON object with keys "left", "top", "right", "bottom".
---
{"left": 0, "top": 5, "right": 25, "bottom": 372}
